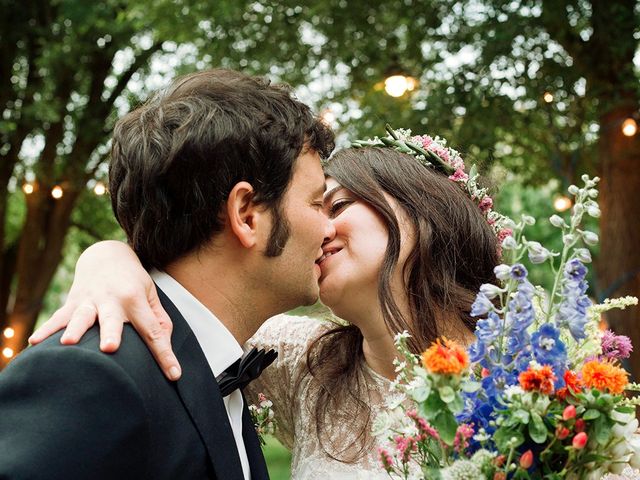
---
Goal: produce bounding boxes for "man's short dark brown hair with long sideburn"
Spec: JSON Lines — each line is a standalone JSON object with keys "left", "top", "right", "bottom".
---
{"left": 109, "top": 69, "right": 334, "bottom": 268}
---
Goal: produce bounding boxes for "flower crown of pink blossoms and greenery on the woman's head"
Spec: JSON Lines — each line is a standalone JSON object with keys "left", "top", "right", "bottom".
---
{"left": 351, "top": 124, "right": 512, "bottom": 243}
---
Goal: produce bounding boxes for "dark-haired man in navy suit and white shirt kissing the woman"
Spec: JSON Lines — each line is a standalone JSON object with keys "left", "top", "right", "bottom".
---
{"left": 0, "top": 70, "right": 335, "bottom": 480}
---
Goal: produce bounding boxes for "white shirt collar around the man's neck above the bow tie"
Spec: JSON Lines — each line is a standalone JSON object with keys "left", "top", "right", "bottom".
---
{"left": 149, "top": 269, "right": 243, "bottom": 377}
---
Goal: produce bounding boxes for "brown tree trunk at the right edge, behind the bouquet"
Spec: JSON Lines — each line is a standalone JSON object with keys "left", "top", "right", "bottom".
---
{"left": 598, "top": 104, "right": 640, "bottom": 381}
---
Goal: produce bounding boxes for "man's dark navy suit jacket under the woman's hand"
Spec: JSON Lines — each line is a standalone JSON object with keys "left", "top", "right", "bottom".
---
{"left": 0, "top": 289, "right": 269, "bottom": 480}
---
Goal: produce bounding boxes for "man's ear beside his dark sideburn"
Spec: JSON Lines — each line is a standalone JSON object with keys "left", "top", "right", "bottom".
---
{"left": 227, "top": 182, "right": 266, "bottom": 248}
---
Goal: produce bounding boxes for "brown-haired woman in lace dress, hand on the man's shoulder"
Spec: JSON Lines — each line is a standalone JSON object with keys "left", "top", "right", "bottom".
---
{"left": 31, "top": 137, "right": 498, "bottom": 480}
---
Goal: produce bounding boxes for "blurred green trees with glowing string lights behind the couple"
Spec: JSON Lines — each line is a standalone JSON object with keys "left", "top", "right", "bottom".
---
{"left": 0, "top": 0, "right": 640, "bottom": 478}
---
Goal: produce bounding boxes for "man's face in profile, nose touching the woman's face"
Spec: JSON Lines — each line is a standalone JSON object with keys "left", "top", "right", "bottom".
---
{"left": 268, "top": 150, "right": 335, "bottom": 309}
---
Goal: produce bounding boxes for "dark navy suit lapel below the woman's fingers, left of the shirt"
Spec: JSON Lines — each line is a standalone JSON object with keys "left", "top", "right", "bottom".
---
{"left": 156, "top": 286, "right": 245, "bottom": 480}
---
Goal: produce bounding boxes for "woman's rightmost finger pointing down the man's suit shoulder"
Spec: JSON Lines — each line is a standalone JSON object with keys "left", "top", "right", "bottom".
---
{"left": 131, "top": 292, "right": 182, "bottom": 381}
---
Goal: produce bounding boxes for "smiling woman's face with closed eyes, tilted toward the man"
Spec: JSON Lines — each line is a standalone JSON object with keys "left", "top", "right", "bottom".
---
{"left": 319, "top": 177, "right": 411, "bottom": 321}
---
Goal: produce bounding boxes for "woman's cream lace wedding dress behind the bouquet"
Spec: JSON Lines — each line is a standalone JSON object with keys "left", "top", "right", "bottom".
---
{"left": 245, "top": 315, "right": 391, "bottom": 480}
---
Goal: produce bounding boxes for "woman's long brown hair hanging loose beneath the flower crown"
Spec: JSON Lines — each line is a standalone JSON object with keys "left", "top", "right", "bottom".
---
{"left": 307, "top": 148, "right": 498, "bottom": 462}
